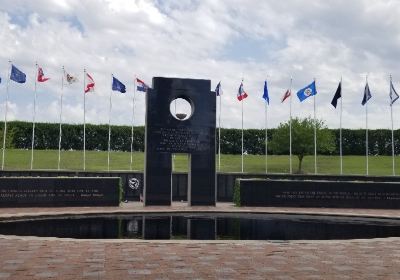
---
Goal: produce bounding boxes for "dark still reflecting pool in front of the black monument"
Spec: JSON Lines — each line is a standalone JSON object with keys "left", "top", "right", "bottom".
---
{"left": 0, "top": 212, "right": 400, "bottom": 240}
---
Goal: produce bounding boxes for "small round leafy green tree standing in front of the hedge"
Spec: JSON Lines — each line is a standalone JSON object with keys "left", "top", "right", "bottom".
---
{"left": 270, "top": 117, "right": 335, "bottom": 173}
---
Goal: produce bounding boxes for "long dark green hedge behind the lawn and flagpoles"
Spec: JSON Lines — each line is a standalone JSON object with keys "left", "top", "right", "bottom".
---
{"left": 0, "top": 121, "right": 400, "bottom": 155}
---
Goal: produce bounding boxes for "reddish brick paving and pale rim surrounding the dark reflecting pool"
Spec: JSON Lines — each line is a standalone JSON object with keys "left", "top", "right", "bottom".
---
{"left": 0, "top": 204, "right": 400, "bottom": 279}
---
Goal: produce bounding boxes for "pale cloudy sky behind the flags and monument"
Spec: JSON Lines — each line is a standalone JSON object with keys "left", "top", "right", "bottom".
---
{"left": 0, "top": 0, "right": 400, "bottom": 128}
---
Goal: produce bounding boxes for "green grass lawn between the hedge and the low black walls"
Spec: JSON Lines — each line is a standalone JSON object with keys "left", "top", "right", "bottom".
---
{"left": 1, "top": 149, "right": 400, "bottom": 175}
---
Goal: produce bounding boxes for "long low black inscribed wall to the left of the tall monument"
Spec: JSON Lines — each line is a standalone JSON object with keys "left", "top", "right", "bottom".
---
{"left": 0, "top": 177, "right": 121, "bottom": 207}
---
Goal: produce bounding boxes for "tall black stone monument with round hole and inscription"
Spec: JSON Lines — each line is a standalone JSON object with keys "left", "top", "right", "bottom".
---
{"left": 144, "top": 77, "right": 216, "bottom": 205}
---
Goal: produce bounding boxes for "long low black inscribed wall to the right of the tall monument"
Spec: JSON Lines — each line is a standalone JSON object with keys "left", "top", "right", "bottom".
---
{"left": 234, "top": 179, "right": 400, "bottom": 209}
